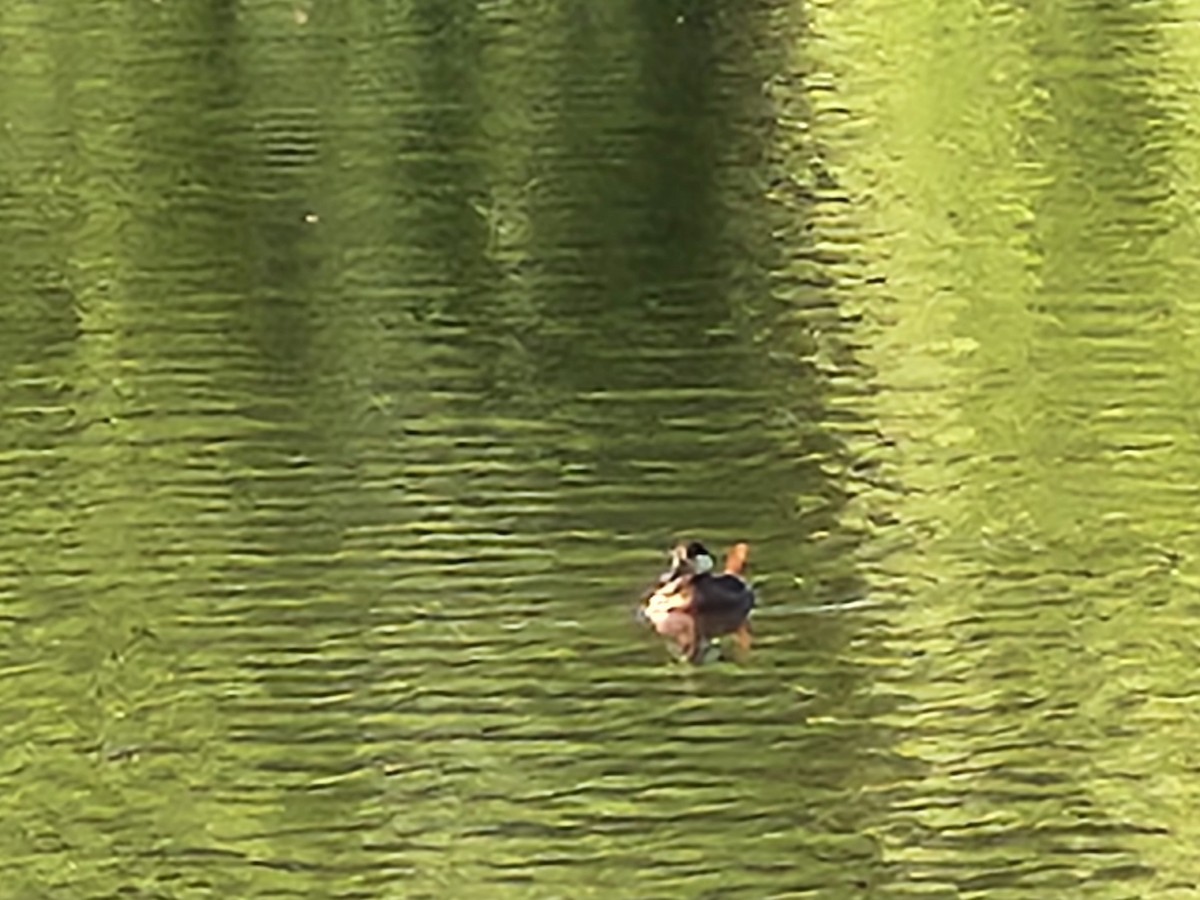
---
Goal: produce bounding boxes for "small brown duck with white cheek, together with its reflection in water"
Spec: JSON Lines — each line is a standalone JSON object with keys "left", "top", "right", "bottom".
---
{"left": 641, "top": 541, "right": 755, "bottom": 662}
